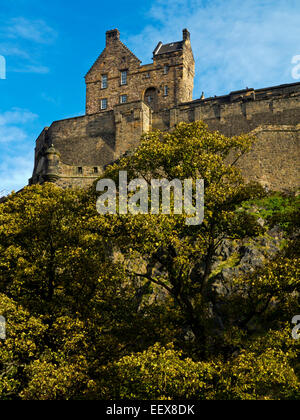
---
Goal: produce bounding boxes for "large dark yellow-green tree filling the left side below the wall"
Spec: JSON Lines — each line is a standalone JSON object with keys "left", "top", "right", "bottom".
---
{"left": 0, "top": 184, "right": 180, "bottom": 399}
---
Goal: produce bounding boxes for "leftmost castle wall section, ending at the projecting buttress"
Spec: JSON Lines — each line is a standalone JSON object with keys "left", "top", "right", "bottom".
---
{"left": 29, "top": 111, "right": 116, "bottom": 187}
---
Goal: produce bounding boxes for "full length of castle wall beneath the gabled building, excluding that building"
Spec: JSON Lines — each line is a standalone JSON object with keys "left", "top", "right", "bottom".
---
{"left": 32, "top": 84, "right": 300, "bottom": 190}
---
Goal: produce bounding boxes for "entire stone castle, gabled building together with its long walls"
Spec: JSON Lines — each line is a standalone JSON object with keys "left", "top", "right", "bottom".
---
{"left": 29, "top": 29, "right": 300, "bottom": 190}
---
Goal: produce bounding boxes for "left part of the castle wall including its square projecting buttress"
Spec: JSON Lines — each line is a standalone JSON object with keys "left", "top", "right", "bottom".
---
{"left": 29, "top": 101, "right": 151, "bottom": 187}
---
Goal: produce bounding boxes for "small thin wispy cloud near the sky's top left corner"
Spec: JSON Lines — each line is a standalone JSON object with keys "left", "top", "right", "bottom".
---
{"left": 6, "top": 17, "right": 57, "bottom": 44}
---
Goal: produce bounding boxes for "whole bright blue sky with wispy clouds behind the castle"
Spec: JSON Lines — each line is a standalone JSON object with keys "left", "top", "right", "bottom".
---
{"left": 0, "top": 0, "right": 300, "bottom": 192}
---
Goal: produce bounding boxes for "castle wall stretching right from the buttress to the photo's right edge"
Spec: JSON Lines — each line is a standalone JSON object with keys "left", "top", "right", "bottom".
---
{"left": 153, "top": 84, "right": 300, "bottom": 190}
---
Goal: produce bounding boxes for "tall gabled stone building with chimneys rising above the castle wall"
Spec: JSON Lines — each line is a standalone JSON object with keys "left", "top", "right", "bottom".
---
{"left": 85, "top": 29, "right": 195, "bottom": 115}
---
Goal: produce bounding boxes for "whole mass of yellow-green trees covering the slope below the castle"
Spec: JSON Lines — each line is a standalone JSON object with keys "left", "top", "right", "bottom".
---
{"left": 0, "top": 123, "right": 300, "bottom": 400}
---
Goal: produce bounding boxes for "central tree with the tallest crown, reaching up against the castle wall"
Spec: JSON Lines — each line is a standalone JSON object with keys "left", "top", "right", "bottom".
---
{"left": 94, "top": 122, "right": 264, "bottom": 352}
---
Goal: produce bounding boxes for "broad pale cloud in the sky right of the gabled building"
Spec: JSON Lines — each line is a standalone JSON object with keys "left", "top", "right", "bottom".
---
{"left": 128, "top": 0, "right": 300, "bottom": 97}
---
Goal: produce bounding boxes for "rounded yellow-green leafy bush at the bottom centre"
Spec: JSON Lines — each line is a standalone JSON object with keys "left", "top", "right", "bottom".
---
{"left": 100, "top": 344, "right": 218, "bottom": 400}
